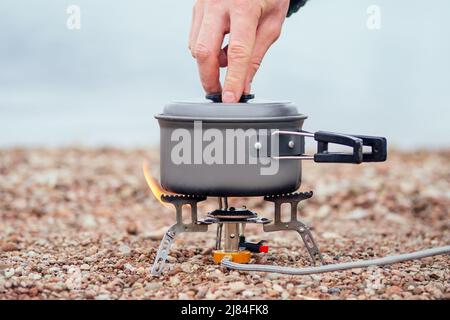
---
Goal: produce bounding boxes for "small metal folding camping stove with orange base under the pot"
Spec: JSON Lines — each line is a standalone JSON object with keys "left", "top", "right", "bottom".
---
{"left": 152, "top": 191, "right": 323, "bottom": 275}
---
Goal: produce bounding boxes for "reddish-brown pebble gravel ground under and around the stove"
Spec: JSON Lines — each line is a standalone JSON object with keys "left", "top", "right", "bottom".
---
{"left": 0, "top": 148, "right": 450, "bottom": 299}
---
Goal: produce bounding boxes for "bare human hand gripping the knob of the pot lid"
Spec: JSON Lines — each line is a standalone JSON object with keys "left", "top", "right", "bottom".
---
{"left": 189, "top": 0, "right": 289, "bottom": 103}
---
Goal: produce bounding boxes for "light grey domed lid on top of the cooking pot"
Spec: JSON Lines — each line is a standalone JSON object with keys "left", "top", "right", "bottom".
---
{"left": 156, "top": 97, "right": 306, "bottom": 121}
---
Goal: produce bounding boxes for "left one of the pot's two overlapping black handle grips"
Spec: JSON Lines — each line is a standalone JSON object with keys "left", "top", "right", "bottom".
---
{"left": 314, "top": 131, "right": 363, "bottom": 163}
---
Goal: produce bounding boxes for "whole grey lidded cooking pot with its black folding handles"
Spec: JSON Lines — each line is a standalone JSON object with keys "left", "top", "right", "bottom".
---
{"left": 155, "top": 94, "right": 387, "bottom": 197}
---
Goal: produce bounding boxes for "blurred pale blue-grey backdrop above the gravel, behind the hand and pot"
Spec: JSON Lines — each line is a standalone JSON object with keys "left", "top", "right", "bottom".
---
{"left": 0, "top": 0, "right": 450, "bottom": 150}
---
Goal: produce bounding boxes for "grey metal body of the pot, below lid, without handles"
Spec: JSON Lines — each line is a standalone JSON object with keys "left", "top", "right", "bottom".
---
{"left": 158, "top": 116, "right": 306, "bottom": 197}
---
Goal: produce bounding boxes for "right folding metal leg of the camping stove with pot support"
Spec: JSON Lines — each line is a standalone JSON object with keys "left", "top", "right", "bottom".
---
{"left": 263, "top": 191, "right": 324, "bottom": 265}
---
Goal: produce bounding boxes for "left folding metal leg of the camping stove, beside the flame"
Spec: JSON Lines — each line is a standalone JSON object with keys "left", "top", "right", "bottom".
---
{"left": 151, "top": 195, "right": 208, "bottom": 276}
